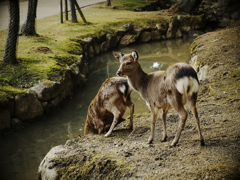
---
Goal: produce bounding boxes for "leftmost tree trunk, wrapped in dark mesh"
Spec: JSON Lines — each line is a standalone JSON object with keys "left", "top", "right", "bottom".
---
{"left": 3, "top": 0, "right": 19, "bottom": 64}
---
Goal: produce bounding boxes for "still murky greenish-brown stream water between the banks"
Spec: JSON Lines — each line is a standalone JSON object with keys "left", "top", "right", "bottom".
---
{"left": 0, "top": 39, "right": 192, "bottom": 180}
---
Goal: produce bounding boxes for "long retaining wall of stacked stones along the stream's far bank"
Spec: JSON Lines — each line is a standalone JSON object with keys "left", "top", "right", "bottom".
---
{"left": 0, "top": 15, "right": 206, "bottom": 130}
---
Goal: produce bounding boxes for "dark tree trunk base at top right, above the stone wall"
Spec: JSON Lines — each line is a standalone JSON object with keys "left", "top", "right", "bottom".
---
{"left": 170, "top": 0, "right": 203, "bottom": 13}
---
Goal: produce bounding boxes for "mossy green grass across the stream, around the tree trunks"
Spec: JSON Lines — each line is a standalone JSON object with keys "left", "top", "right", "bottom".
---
{"left": 0, "top": 0, "right": 168, "bottom": 100}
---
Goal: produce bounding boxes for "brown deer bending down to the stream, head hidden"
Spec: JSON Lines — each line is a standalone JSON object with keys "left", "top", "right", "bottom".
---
{"left": 84, "top": 77, "right": 134, "bottom": 137}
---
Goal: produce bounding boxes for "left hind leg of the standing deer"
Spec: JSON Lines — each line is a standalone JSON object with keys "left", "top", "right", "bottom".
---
{"left": 171, "top": 106, "right": 187, "bottom": 146}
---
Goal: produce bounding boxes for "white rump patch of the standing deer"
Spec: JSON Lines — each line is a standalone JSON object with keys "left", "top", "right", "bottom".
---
{"left": 175, "top": 77, "right": 199, "bottom": 95}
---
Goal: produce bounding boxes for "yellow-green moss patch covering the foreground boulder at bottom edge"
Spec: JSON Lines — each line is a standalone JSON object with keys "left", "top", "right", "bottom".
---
{"left": 54, "top": 154, "right": 130, "bottom": 180}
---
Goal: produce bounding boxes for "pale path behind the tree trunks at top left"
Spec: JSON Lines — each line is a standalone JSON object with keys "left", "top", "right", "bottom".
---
{"left": 0, "top": 0, "right": 103, "bottom": 30}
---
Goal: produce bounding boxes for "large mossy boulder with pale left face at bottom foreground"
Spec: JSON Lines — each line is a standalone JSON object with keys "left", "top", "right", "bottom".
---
{"left": 38, "top": 139, "right": 133, "bottom": 180}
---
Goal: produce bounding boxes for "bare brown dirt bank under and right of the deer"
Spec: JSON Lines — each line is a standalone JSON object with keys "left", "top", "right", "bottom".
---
{"left": 39, "top": 22, "right": 240, "bottom": 179}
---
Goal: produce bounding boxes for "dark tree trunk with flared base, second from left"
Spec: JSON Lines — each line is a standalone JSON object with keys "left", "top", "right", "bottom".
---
{"left": 21, "top": 0, "right": 38, "bottom": 36}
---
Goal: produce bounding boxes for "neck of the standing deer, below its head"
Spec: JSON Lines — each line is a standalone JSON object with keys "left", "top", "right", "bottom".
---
{"left": 128, "top": 66, "right": 148, "bottom": 91}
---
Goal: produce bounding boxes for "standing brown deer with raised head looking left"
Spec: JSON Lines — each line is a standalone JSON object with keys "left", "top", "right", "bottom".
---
{"left": 113, "top": 51, "right": 204, "bottom": 146}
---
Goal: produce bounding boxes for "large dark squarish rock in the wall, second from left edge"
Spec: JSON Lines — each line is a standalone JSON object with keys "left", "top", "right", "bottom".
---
{"left": 15, "top": 92, "right": 44, "bottom": 121}
